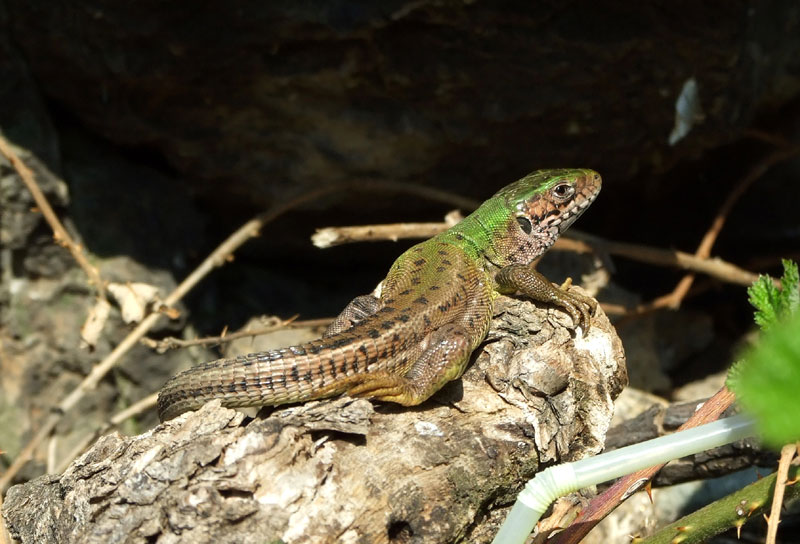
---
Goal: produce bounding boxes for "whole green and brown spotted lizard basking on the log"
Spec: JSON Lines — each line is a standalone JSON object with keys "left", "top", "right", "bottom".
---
{"left": 158, "top": 169, "right": 601, "bottom": 420}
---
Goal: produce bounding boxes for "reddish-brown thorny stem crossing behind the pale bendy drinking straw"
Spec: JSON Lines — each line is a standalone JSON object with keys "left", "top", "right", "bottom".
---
{"left": 552, "top": 387, "right": 735, "bottom": 544}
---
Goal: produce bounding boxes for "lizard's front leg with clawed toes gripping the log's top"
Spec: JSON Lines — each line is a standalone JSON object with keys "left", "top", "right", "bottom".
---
{"left": 495, "top": 264, "right": 597, "bottom": 330}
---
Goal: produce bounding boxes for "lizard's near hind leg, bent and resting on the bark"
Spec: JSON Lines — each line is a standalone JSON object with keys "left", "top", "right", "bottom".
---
{"left": 347, "top": 323, "right": 472, "bottom": 406}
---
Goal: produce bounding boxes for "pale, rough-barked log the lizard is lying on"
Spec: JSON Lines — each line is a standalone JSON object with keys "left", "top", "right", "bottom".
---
{"left": 4, "top": 299, "right": 627, "bottom": 544}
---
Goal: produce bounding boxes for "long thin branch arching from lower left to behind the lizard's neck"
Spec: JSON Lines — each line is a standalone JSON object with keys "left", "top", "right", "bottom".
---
{"left": 0, "top": 177, "right": 476, "bottom": 493}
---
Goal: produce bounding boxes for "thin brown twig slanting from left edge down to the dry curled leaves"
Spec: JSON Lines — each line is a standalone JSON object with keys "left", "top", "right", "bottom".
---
{"left": 0, "top": 134, "right": 106, "bottom": 302}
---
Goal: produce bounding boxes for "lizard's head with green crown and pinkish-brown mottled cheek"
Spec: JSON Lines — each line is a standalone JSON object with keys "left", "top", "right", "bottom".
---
{"left": 495, "top": 169, "right": 602, "bottom": 262}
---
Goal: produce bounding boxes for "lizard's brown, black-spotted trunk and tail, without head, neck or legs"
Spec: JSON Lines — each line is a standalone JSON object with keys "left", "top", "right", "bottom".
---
{"left": 158, "top": 238, "right": 492, "bottom": 420}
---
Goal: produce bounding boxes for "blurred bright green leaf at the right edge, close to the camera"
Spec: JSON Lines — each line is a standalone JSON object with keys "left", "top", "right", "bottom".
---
{"left": 728, "top": 312, "right": 800, "bottom": 448}
